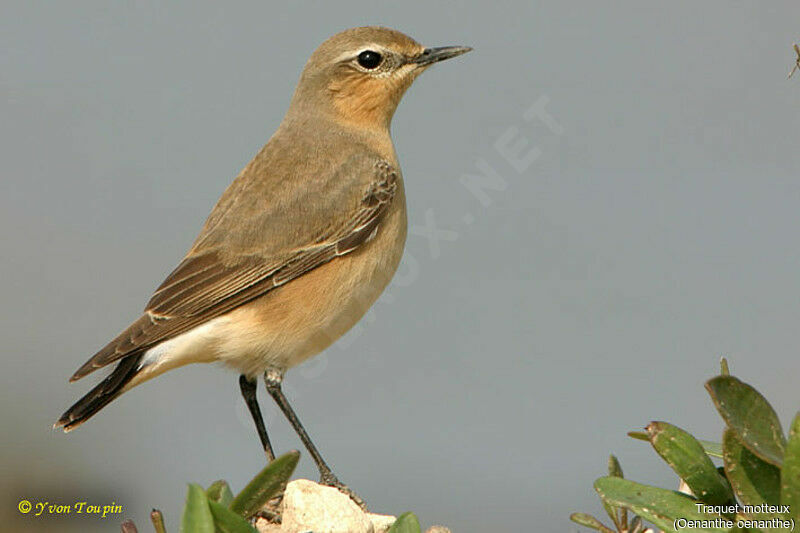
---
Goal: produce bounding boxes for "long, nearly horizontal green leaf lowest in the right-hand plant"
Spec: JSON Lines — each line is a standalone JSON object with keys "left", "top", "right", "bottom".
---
{"left": 594, "top": 477, "right": 730, "bottom": 533}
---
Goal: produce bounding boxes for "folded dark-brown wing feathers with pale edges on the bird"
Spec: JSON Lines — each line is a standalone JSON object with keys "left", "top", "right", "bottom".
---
{"left": 70, "top": 162, "right": 397, "bottom": 381}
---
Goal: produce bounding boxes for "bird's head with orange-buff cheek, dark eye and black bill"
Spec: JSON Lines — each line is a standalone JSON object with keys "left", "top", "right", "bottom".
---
{"left": 290, "top": 26, "right": 471, "bottom": 130}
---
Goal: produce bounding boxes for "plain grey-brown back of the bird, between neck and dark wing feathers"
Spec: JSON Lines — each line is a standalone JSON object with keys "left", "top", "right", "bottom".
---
{"left": 190, "top": 119, "right": 397, "bottom": 257}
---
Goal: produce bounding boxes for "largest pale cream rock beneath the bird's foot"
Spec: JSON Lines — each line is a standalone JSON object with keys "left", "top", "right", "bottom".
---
{"left": 280, "top": 479, "right": 375, "bottom": 533}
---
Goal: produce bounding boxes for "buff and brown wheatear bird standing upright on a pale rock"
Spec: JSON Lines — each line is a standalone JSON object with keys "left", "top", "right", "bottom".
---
{"left": 54, "top": 26, "right": 471, "bottom": 506}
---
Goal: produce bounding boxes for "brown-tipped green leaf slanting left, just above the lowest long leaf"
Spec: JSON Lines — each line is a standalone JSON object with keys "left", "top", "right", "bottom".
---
{"left": 646, "top": 422, "right": 733, "bottom": 505}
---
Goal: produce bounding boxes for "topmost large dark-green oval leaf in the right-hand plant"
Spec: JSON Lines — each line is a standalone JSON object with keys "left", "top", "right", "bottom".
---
{"left": 706, "top": 376, "right": 786, "bottom": 466}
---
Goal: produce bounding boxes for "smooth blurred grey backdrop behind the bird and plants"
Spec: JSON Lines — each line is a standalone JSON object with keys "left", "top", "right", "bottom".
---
{"left": 0, "top": 1, "right": 800, "bottom": 533}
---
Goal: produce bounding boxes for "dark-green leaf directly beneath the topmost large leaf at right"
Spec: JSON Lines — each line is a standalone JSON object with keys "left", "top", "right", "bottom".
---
{"left": 722, "top": 428, "right": 781, "bottom": 505}
